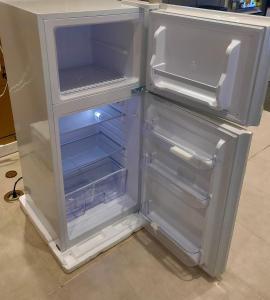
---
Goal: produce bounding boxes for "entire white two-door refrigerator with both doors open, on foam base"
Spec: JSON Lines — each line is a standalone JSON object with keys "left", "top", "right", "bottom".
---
{"left": 0, "top": 0, "right": 270, "bottom": 277}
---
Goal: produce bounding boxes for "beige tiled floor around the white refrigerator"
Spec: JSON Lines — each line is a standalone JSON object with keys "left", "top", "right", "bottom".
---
{"left": 0, "top": 112, "right": 270, "bottom": 300}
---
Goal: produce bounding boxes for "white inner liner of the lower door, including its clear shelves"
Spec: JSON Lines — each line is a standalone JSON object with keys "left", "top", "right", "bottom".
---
{"left": 142, "top": 95, "right": 247, "bottom": 265}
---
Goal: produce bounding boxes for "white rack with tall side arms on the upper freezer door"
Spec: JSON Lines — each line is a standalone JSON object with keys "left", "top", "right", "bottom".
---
{"left": 150, "top": 35, "right": 241, "bottom": 110}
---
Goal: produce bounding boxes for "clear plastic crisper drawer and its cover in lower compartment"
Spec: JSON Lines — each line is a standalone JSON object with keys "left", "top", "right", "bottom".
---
{"left": 64, "top": 158, "right": 127, "bottom": 221}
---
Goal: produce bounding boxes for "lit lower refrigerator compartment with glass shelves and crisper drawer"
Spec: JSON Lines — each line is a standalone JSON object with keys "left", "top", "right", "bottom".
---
{"left": 59, "top": 97, "right": 140, "bottom": 239}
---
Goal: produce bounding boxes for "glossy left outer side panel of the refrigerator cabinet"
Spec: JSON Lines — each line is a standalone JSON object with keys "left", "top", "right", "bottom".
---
{"left": 0, "top": 3, "right": 63, "bottom": 244}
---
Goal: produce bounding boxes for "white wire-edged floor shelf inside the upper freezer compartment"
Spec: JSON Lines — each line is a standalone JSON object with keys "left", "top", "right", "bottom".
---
{"left": 59, "top": 65, "right": 126, "bottom": 92}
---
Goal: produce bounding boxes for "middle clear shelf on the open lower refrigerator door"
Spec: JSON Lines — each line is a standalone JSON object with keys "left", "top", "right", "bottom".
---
{"left": 148, "top": 162, "right": 211, "bottom": 209}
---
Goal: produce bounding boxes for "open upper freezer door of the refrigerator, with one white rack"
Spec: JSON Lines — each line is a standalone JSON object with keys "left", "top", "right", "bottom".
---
{"left": 147, "top": 5, "right": 270, "bottom": 126}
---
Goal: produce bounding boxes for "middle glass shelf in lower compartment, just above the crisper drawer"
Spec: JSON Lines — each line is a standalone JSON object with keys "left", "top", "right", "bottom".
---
{"left": 61, "top": 132, "right": 124, "bottom": 176}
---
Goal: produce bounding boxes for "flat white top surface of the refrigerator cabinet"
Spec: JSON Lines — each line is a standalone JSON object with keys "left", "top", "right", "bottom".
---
{"left": 1, "top": 0, "right": 139, "bottom": 19}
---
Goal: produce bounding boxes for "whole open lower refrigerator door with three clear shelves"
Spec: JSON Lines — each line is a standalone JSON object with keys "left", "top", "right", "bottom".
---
{"left": 141, "top": 93, "right": 251, "bottom": 276}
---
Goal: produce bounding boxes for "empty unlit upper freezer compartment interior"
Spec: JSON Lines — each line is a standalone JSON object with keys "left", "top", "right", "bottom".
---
{"left": 55, "top": 20, "right": 137, "bottom": 93}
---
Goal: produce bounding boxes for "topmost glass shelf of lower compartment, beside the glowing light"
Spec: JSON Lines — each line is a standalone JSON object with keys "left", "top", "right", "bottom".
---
{"left": 59, "top": 105, "right": 125, "bottom": 135}
